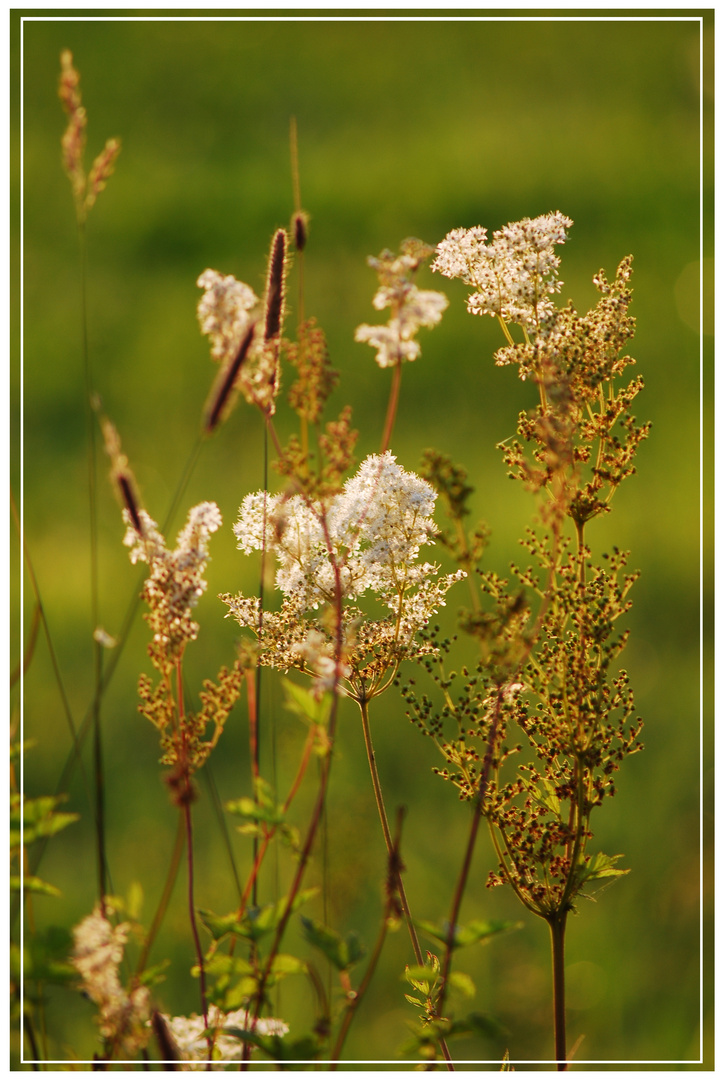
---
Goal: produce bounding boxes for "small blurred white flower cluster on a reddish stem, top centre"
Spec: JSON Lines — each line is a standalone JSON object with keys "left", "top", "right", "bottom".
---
{"left": 354, "top": 253, "right": 448, "bottom": 367}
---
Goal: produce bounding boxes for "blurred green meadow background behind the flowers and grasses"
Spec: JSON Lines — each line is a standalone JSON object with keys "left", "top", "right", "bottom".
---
{"left": 13, "top": 16, "right": 710, "bottom": 1069}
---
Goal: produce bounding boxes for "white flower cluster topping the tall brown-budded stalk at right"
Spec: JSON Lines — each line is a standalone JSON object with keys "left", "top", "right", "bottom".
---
{"left": 432, "top": 211, "right": 573, "bottom": 334}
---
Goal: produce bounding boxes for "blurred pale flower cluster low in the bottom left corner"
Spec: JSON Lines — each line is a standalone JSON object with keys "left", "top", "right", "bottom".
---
{"left": 71, "top": 905, "right": 150, "bottom": 1057}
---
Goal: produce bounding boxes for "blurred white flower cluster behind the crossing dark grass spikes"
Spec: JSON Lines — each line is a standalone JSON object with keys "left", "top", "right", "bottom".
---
{"left": 197, "top": 270, "right": 279, "bottom": 414}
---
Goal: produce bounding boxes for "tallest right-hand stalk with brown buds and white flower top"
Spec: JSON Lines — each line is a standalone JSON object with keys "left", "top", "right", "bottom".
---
{"left": 407, "top": 213, "right": 650, "bottom": 1069}
